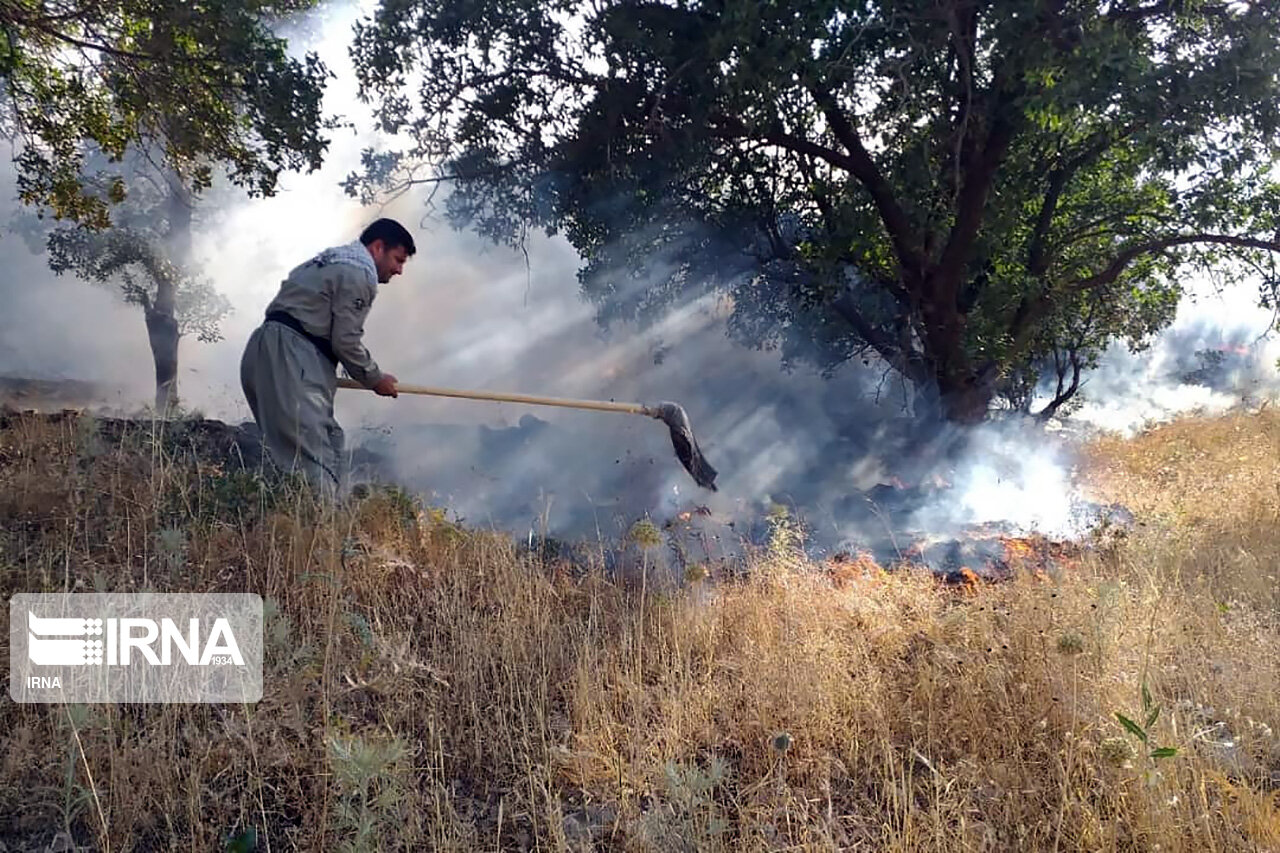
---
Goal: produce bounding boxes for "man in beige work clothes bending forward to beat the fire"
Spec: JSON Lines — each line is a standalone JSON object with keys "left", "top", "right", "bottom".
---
{"left": 241, "top": 219, "right": 417, "bottom": 497}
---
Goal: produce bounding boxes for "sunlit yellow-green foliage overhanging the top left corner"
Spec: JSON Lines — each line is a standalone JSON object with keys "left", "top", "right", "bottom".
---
{"left": 0, "top": 0, "right": 330, "bottom": 229}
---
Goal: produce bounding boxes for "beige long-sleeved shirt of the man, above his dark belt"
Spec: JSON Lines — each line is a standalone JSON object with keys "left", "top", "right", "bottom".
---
{"left": 266, "top": 252, "right": 383, "bottom": 388}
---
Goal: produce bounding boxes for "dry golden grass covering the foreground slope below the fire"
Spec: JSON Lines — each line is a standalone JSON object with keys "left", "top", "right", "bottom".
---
{"left": 0, "top": 416, "right": 1280, "bottom": 850}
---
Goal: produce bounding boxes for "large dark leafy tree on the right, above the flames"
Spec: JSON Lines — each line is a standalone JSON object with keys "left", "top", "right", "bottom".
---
{"left": 347, "top": 0, "right": 1280, "bottom": 423}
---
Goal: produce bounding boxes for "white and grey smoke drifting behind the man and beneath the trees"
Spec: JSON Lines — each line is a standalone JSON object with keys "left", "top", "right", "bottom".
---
{"left": 0, "top": 0, "right": 1277, "bottom": 558}
